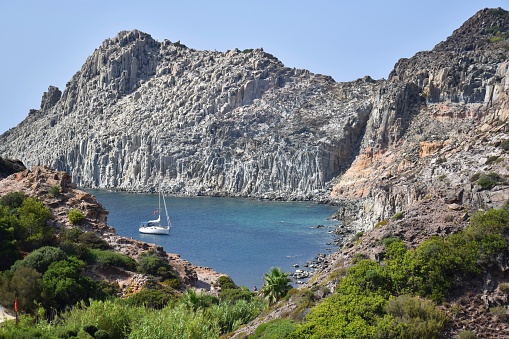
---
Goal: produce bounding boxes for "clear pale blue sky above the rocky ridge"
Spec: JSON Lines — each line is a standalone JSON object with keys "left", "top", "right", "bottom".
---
{"left": 0, "top": 0, "right": 509, "bottom": 133}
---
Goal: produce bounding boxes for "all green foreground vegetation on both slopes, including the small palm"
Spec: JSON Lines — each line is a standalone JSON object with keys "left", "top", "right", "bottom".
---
{"left": 0, "top": 189, "right": 509, "bottom": 338}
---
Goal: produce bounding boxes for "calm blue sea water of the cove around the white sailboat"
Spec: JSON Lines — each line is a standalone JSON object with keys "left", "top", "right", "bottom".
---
{"left": 87, "top": 190, "right": 339, "bottom": 289}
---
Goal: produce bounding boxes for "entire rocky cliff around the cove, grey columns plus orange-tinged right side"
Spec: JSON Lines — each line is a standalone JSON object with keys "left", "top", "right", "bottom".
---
{"left": 0, "top": 9, "right": 509, "bottom": 229}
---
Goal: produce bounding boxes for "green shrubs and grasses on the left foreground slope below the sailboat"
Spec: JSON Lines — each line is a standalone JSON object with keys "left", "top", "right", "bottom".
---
{"left": 0, "top": 189, "right": 267, "bottom": 338}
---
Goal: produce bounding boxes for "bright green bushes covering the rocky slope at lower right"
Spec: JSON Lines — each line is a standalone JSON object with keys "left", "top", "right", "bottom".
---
{"left": 246, "top": 206, "right": 509, "bottom": 338}
